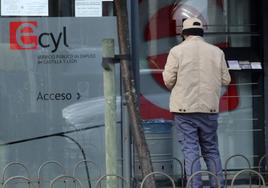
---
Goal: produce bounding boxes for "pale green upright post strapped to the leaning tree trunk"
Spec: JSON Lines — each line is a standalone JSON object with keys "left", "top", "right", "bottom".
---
{"left": 102, "top": 39, "right": 119, "bottom": 188}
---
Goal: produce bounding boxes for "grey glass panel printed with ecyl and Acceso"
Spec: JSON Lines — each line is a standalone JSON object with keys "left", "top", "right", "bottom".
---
{"left": 0, "top": 0, "right": 121, "bottom": 187}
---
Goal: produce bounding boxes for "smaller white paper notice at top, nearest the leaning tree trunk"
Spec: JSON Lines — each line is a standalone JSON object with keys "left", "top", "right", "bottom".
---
{"left": 75, "top": 0, "right": 102, "bottom": 17}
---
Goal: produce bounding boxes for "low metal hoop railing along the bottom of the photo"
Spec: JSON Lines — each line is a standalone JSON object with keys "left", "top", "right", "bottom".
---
{"left": 0, "top": 154, "right": 268, "bottom": 188}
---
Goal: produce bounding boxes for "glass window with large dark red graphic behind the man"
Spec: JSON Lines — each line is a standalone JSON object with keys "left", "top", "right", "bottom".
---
{"left": 138, "top": 0, "right": 263, "bottom": 172}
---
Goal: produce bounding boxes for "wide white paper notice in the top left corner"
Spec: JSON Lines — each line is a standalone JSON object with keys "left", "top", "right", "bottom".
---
{"left": 1, "top": 0, "right": 48, "bottom": 16}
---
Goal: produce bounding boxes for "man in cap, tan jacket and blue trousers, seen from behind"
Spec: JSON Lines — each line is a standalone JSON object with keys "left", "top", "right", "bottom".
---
{"left": 163, "top": 18, "right": 231, "bottom": 188}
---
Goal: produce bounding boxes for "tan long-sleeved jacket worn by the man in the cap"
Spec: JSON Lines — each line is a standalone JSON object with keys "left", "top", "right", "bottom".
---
{"left": 163, "top": 36, "right": 231, "bottom": 113}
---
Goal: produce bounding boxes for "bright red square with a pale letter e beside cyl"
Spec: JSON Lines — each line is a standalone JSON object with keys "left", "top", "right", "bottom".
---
{"left": 9, "top": 21, "right": 38, "bottom": 50}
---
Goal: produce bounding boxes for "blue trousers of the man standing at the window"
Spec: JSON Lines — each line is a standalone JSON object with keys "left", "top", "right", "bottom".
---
{"left": 175, "top": 113, "right": 224, "bottom": 188}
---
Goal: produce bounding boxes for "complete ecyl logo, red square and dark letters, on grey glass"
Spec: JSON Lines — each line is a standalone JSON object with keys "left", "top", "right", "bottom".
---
{"left": 9, "top": 21, "right": 69, "bottom": 53}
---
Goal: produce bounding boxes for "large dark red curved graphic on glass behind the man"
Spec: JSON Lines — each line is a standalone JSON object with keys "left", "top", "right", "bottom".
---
{"left": 140, "top": 0, "right": 240, "bottom": 120}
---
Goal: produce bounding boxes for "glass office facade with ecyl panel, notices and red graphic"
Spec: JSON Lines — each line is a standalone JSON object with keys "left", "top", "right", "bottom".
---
{"left": 0, "top": 0, "right": 268, "bottom": 187}
